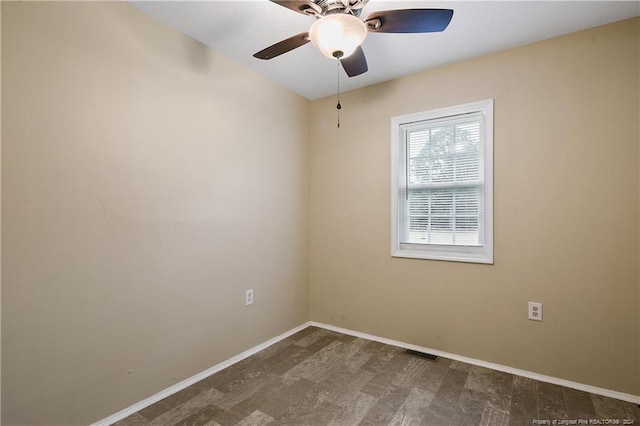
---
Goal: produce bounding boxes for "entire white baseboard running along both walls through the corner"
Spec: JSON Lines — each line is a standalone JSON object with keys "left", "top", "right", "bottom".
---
{"left": 92, "top": 321, "right": 640, "bottom": 426}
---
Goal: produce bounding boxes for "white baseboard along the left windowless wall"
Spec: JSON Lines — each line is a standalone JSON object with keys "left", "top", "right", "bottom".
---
{"left": 92, "top": 322, "right": 310, "bottom": 426}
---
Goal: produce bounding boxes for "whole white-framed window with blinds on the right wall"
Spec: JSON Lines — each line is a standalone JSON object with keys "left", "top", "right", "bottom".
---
{"left": 391, "top": 100, "right": 493, "bottom": 263}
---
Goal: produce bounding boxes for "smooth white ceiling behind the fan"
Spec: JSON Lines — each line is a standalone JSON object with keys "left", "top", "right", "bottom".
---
{"left": 129, "top": 0, "right": 640, "bottom": 99}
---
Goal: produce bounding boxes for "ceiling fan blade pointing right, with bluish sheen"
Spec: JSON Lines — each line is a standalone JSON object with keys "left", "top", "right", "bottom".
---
{"left": 365, "top": 9, "right": 453, "bottom": 33}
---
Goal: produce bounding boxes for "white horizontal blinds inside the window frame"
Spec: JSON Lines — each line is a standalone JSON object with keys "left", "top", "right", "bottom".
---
{"left": 400, "top": 113, "right": 484, "bottom": 246}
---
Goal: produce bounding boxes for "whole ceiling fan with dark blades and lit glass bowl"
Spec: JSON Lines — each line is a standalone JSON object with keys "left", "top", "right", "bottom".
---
{"left": 253, "top": 0, "right": 453, "bottom": 77}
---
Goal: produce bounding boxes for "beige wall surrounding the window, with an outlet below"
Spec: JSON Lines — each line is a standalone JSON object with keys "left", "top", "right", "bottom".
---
{"left": 310, "top": 19, "right": 640, "bottom": 395}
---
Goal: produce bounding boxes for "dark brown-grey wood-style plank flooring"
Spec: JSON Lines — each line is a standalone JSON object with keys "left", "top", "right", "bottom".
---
{"left": 116, "top": 327, "right": 640, "bottom": 426}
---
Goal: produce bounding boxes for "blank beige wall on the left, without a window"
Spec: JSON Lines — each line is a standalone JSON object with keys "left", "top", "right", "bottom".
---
{"left": 2, "top": 2, "right": 309, "bottom": 425}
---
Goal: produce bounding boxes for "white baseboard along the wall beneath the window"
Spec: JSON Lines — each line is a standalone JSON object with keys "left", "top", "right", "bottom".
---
{"left": 309, "top": 321, "right": 640, "bottom": 404}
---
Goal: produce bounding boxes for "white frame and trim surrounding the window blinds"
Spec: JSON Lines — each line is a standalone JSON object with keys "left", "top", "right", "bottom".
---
{"left": 391, "top": 99, "right": 493, "bottom": 264}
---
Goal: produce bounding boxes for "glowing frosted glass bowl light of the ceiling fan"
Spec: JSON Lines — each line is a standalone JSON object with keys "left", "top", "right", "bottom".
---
{"left": 309, "top": 13, "right": 367, "bottom": 59}
